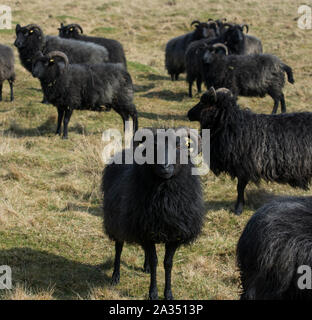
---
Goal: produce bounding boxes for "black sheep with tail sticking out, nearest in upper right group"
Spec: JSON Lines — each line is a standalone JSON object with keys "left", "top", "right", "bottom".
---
{"left": 203, "top": 43, "right": 294, "bottom": 113}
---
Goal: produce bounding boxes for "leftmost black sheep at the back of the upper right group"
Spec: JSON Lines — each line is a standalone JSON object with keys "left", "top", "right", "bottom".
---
{"left": 165, "top": 20, "right": 217, "bottom": 81}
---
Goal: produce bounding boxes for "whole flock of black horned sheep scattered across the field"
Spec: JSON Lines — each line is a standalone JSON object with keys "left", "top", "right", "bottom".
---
{"left": 0, "top": 6, "right": 312, "bottom": 300}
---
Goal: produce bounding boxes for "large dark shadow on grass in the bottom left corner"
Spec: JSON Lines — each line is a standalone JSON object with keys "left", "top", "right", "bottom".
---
{"left": 0, "top": 248, "right": 113, "bottom": 299}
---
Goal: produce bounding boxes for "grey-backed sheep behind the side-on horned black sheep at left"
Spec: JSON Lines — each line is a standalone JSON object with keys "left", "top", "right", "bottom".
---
{"left": 14, "top": 24, "right": 108, "bottom": 103}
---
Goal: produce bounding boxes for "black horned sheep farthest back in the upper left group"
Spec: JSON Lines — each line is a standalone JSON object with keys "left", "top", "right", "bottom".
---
{"left": 58, "top": 23, "right": 127, "bottom": 68}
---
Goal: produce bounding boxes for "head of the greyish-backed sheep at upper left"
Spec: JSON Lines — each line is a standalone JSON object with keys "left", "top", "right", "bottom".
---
{"left": 14, "top": 24, "right": 42, "bottom": 49}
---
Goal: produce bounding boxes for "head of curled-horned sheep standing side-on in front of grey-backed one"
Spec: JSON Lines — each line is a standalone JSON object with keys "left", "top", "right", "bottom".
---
{"left": 32, "top": 56, "right": 65, "bottom": 80}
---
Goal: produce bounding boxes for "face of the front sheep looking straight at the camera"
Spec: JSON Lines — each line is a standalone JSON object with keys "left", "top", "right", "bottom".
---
{"left": 136, "top": 128, "right": 197, "bottom": 179}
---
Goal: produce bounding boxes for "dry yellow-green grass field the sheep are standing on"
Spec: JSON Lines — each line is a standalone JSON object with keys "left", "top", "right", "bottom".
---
{"left": 0, "top": 0, "right": 312, "bottom": 299}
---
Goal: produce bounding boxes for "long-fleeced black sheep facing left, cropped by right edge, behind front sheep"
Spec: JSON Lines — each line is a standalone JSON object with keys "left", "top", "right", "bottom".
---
{"left": 188, "top": 88, "right": 312, "bottom": 215}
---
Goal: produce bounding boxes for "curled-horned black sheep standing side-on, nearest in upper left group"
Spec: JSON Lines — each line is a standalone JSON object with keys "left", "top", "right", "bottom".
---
{"left": 32, "top": 51, "right": 138, "bottom": 139}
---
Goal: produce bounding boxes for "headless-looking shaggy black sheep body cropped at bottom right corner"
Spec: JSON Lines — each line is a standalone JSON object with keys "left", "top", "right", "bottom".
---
{"left": 237, "top": 197, "right": 312, "bottom": 300}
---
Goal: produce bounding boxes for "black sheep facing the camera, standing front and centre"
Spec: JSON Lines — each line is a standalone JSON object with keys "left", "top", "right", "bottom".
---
{"left": 102, "top": 128, "right": 204, "bottom": 300}
